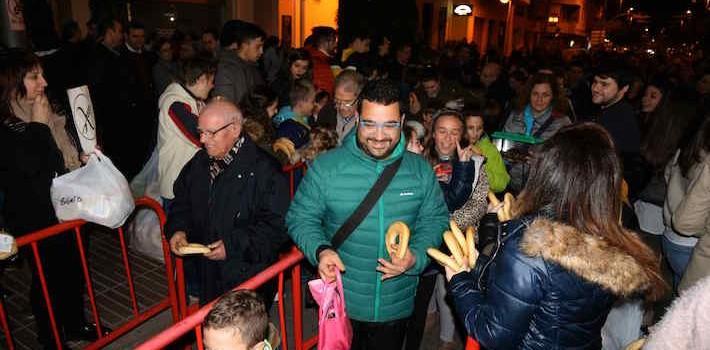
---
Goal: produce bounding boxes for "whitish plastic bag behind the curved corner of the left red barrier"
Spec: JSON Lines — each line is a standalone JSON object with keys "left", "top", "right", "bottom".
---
{"left": 126, "top": 150, "right": 165, "bottom": 262}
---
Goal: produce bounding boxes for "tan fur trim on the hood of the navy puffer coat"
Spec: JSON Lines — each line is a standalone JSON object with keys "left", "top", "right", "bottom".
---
{"left": 520, "top": 219, "right": 651, "bottom": 297}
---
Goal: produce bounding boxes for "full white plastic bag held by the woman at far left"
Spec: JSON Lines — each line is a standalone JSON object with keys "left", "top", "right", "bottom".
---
{"left": 50, "top": 151, "right": 135, "bottom": 228}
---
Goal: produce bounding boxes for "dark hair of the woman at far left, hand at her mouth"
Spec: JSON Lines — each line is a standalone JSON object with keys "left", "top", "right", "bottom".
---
{"left": 0, "top": 49, "right": 41, "bottom": 122}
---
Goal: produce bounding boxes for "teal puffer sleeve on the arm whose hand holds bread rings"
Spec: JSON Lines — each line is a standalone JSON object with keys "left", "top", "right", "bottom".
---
{"left": 408, "top": 159, "right": 449, "bottom": 275}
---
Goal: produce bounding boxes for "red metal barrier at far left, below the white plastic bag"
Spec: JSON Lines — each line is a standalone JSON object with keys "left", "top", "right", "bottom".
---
{"left": 0, "top": 197, "right": 182, "bottom": 350}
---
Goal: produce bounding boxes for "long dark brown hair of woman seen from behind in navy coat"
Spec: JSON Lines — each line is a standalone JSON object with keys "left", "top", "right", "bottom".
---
{"left": 513, "top": 123, "right": 665, "bottom": 300}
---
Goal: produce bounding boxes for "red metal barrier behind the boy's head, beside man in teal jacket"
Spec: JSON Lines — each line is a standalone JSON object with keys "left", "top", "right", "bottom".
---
{"left": 136, "top": 247, "right": 318, "bottom": 350}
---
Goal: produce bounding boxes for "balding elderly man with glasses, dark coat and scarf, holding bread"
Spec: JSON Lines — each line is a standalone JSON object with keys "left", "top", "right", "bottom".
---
{"left": 165, "top": 100, "right": 289, "bottom": 305}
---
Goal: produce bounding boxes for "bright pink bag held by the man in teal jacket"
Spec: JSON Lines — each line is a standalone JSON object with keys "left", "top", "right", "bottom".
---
{"left": 308, "top": 269, "right": 353, "bottom": 350}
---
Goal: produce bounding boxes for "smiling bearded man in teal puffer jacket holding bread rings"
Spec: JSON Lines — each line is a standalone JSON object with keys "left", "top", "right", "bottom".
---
{"left": 286, "top": 81, "right": 448, "bottom": 350}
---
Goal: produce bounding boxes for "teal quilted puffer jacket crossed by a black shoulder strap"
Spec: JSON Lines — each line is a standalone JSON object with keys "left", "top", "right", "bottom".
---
{"left": 286, "top": 132, "right": 448, "bottom": 322}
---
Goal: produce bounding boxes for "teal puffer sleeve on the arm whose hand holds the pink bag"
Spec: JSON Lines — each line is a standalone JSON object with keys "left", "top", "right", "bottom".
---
{"left": 286, "top": 161, "right": 330, "bottom": 266}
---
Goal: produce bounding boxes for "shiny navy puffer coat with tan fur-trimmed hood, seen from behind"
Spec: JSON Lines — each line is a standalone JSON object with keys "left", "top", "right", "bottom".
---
{"left": 449, "top": 219, "right": 649, "bottom": 350}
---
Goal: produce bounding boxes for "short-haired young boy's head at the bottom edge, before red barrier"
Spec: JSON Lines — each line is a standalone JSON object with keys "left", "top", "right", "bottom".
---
{"left": 202, "top": 290, "right": 269, "bottom": 350}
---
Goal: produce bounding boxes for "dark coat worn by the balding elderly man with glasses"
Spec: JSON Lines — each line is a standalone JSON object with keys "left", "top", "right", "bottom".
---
{"left": 165, "top": 137, "right": 289, "bottom": 303}
